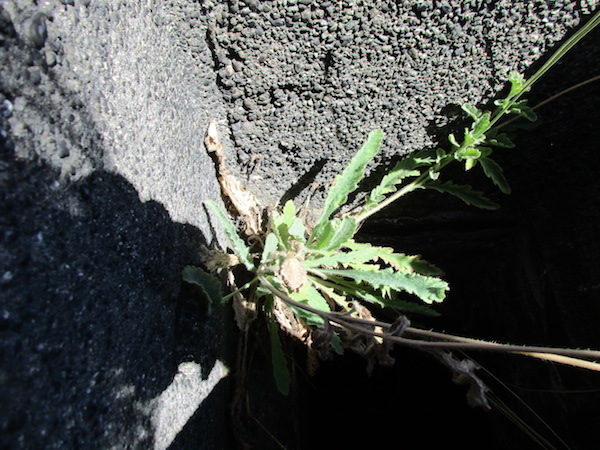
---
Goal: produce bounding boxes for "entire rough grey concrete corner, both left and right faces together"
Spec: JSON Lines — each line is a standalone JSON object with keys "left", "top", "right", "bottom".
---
{"left": 0, "top": 0, "right": 596, "bottom": 449}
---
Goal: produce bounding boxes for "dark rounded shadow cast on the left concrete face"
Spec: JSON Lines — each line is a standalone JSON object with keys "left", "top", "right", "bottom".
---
{"left": 0, "top": 148, "right": 233, "bottom": 448}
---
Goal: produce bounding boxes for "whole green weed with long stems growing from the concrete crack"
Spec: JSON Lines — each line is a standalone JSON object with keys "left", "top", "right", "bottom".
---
{"left": 183, "top": 13, "right": 600, "bottom": 407}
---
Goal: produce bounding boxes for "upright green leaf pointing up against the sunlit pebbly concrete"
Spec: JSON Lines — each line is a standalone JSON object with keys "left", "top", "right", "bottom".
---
{"left": 311, "top": 130, "right": 383, "bottom": 240}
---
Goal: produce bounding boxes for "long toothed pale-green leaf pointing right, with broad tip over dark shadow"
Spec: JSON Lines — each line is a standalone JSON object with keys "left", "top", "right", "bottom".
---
{"left": 319, "top": 269, "right": 448, "bottom": 303}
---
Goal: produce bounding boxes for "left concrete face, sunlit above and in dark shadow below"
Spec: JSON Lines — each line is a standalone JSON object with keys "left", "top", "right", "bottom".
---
{"left": 0, "top": 1, "right": 231, "bottom": 448}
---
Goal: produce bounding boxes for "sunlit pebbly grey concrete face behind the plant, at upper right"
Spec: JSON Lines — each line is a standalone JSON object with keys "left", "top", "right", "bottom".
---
{"left": 200, "top": 0, "right": 585, "bottom": 207}
